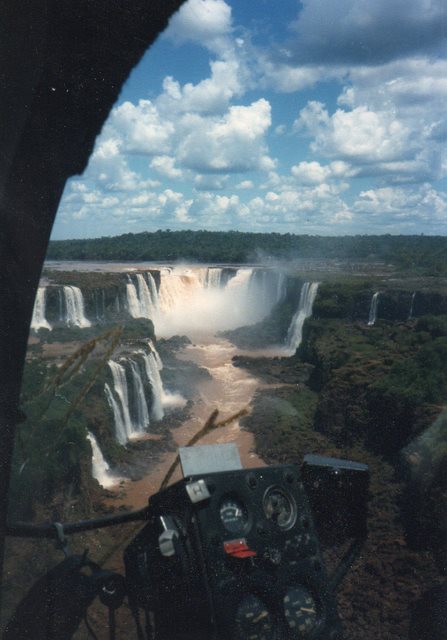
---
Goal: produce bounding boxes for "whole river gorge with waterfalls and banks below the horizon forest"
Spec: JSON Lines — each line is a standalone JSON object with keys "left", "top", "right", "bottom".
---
{"left": 4, "top": 262, "right": 447, "bottom": 640}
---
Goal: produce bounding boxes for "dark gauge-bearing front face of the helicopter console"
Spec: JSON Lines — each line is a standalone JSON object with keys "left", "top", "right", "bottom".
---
{"left": 214, "top": 478, "right": 325, "bottom": 640}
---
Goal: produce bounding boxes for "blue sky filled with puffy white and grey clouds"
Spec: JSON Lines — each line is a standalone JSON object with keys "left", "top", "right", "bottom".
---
{"left": 52, "top": 0, "right": 447, "bottom": 239}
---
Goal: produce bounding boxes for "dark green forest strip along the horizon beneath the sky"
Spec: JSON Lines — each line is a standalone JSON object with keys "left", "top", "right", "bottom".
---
{"left": 47, "top": 229, "right": 447, "bottom": 275}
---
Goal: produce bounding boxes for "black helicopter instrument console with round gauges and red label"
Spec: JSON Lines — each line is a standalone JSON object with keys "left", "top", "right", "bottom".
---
{"left": 124, "top": 465, "right": 341, "bottom": 640}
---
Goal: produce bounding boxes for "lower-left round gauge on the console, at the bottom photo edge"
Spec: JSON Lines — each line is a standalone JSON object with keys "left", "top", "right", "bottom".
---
{"left": 236, "top": 594, "right": 277, "bottom": 640}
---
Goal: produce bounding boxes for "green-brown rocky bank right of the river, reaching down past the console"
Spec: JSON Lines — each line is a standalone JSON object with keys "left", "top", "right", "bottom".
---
{"left": 241, "top": 302, "right": 447, "bottom": 640}
